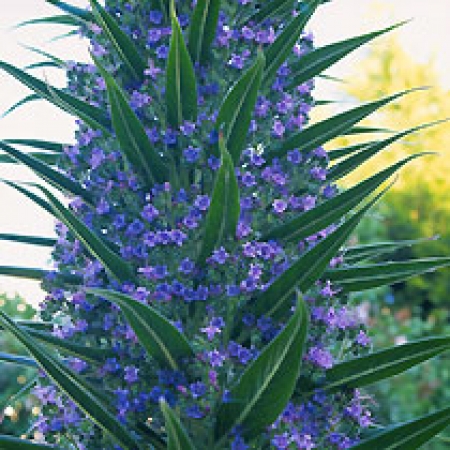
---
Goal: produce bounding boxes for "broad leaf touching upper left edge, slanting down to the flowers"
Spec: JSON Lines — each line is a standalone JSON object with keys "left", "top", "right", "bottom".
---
{"left": 0, "top": 61, "right": 111, "bottom": 132}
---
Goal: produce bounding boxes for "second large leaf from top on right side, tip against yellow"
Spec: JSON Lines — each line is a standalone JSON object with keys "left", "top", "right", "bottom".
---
{"left": 268, "top": 90, "right": 422, "bottom": 160}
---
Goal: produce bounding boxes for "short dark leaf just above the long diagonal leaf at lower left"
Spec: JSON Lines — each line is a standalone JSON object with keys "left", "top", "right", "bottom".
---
{"left": 20, "top": 326, "right": 114, "bottom": 363}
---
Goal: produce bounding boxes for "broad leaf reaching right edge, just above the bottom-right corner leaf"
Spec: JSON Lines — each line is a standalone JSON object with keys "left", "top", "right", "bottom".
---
{"left": 320, "top": 337, "right": 450, "bottom": 392}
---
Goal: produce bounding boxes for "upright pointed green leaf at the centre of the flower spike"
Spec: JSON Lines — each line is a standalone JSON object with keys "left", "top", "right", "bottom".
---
{"left": 198, "top": 136, "right": 240, "bottom": 265}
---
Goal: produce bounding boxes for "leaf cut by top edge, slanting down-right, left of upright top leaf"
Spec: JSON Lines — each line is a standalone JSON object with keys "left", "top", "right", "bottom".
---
{"left": 89, "top": 0, "right": 146, "bottom": 82}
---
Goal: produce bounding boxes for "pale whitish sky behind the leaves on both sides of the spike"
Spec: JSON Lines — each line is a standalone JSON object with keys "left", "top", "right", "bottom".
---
{"left": 0, "top": 0, "right": 450, "bottom": 303}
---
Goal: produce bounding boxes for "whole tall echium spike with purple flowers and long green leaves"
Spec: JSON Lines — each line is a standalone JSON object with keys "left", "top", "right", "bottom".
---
{"left": 0, "top": 0, "right": 450, "bottom": 450}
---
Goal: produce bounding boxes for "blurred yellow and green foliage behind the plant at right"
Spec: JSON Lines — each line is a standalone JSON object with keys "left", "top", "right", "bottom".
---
{"left": 330, "top": 37, "right": 450, "bottom": 450}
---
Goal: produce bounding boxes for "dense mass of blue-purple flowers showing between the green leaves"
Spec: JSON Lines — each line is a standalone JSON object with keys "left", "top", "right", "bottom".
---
{"left": 35, "top": 0, "right": 371, "bottom": 450}
